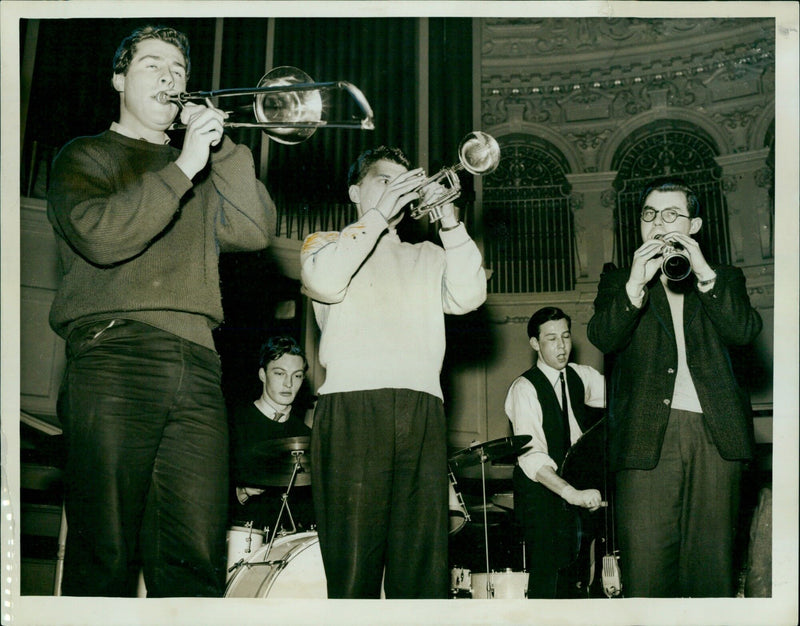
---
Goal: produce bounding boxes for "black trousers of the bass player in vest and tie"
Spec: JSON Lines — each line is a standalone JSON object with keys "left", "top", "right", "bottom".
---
{"left": 513, "top": 465, "right": 579, "bottom": 598}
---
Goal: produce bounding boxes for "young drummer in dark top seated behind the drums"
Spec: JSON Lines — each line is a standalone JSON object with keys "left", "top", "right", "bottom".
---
{"left": 230, "top": 336, "right": 314, "bottom": 530}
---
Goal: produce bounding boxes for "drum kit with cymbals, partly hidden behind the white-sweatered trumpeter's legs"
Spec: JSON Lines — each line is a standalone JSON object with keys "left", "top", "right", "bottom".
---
{"left": 225, "top": 435, "right": 531, "bottom": 599}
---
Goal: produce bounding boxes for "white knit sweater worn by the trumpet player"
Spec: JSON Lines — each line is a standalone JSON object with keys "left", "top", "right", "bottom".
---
{"left": 300, "top": 209, "right": 486, "bottom": 398}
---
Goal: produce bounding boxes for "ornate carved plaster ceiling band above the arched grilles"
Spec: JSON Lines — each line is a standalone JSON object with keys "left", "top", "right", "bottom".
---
{"left": 481, "top": 18, "right": 775, "bottom": 171}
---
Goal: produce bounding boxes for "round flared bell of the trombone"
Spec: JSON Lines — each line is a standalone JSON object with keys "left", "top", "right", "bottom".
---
{"left": 253, "top": 65, "right": 322, "bottom": 145}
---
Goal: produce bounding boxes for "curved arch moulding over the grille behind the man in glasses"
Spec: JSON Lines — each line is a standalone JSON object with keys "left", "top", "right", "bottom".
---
{"left": 597, "top": 108, "right": 732, "bottom": 172}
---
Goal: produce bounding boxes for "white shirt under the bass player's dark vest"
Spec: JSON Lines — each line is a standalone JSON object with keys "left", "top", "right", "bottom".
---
{"left": 505, "top": 359, "right": 605, "bottom": 482}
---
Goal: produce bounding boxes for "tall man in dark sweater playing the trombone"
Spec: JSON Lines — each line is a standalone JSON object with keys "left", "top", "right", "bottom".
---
{"left": 47, "top": 26, "right": 275, "bottom": 596}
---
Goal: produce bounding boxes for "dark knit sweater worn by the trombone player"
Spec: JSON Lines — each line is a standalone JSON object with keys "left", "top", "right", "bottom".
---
{"left": 47, "top": 130, "right": 275, "bottom": 349}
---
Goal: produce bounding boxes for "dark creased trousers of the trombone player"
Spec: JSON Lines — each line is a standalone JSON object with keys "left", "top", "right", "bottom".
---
{"left": 58, "top": 320, "right": 228, "bottom": 597}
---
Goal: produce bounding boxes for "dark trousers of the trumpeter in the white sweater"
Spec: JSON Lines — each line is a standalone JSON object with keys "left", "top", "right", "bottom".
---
{"left": 311, "top": 389, "right": 449, "bottom": 598}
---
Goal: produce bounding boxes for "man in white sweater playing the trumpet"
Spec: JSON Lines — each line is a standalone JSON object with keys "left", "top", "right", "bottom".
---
{"left": 301, "top": 146, "right": 486, "bottom": 598}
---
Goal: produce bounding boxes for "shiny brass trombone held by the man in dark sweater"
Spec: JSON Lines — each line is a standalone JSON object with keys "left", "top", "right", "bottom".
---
{"left": 162, "top": 65, "right": 375, "bottom": 145}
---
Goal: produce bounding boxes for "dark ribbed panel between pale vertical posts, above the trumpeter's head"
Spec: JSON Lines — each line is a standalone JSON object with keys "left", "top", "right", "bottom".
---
{"left": 267, "top": 18, "right": 417, "bottom": 203}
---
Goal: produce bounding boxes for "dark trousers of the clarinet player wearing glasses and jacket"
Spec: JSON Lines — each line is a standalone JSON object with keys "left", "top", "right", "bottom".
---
{"left": 616, "top": 410, "right": 741, "bottom": 598}
